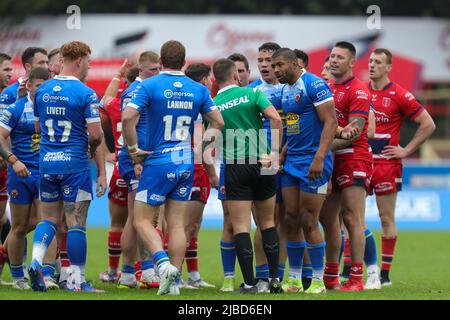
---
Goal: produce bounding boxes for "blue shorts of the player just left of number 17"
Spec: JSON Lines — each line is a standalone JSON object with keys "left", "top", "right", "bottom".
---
{"left": 6, "top": 169, "right": 40, "bottom": 204}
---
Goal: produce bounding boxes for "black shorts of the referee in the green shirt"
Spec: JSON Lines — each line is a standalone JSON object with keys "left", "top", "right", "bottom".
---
{"left": 225, "top": 164, "right": 276, "bottom": 201}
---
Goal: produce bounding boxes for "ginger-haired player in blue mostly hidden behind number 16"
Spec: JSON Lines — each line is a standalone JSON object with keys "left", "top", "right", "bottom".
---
{"left": 118, "top": 51, "right": 161, "bottom": 289}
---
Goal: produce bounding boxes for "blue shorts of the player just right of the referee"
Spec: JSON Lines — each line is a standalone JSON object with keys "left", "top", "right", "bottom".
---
{"left": 281, "top": 155, "right": 333, "bottom": 194}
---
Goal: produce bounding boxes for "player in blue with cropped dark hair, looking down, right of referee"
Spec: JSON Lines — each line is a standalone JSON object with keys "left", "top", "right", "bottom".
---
{"left": 272, "top": 48, "right": 337, "bottom": 293}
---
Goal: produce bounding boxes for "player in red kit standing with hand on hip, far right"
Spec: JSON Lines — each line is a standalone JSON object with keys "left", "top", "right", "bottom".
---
{"left": 369, "top": 48, "right": 436, "bottom": 286}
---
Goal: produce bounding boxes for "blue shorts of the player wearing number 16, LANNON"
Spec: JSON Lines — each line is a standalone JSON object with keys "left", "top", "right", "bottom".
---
{"left": 135, "top": 163, "right": 194, "bottom": 206}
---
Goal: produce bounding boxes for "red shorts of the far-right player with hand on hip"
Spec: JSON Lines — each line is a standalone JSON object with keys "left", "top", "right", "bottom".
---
{"left": 369, "top": 162, "right": 403, "bottom": 196}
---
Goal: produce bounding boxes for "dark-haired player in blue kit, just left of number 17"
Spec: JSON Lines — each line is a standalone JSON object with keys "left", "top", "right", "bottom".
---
{"left": 0, "top": 68, "right": 51, "bottom": 290}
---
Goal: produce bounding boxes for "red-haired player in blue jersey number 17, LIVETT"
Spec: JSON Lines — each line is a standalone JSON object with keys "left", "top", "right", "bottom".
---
{"left": 29, "top": 41, "right": 106, "bottom": 292}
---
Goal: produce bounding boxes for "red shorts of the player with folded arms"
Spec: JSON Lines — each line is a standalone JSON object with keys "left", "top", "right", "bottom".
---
{"left": 331, "top": 159, "right": 373, "bottom": 192}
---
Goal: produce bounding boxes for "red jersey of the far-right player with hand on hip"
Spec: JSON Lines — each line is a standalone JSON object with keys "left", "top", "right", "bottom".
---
{"left": 368, "top": 82, "right": 425, "bottom": 163}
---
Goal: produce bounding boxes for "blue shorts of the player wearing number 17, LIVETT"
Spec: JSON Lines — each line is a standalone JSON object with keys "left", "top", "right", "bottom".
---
{"left": 39, "top": 170, "right": 92, "bottom": 202}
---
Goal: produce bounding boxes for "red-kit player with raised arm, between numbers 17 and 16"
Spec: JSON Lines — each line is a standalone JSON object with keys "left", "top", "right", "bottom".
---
{"left": 99, "top": 60, "right": 134, "bottom": 282}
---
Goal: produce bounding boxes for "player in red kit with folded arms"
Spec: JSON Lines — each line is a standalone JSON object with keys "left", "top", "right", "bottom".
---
{"left": 320, "top": 42, "right": 373, "bottom": 291}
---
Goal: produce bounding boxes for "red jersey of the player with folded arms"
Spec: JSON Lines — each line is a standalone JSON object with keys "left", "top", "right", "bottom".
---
{"left": 330, "top": 76, "right": 372, "bottom": 162}
